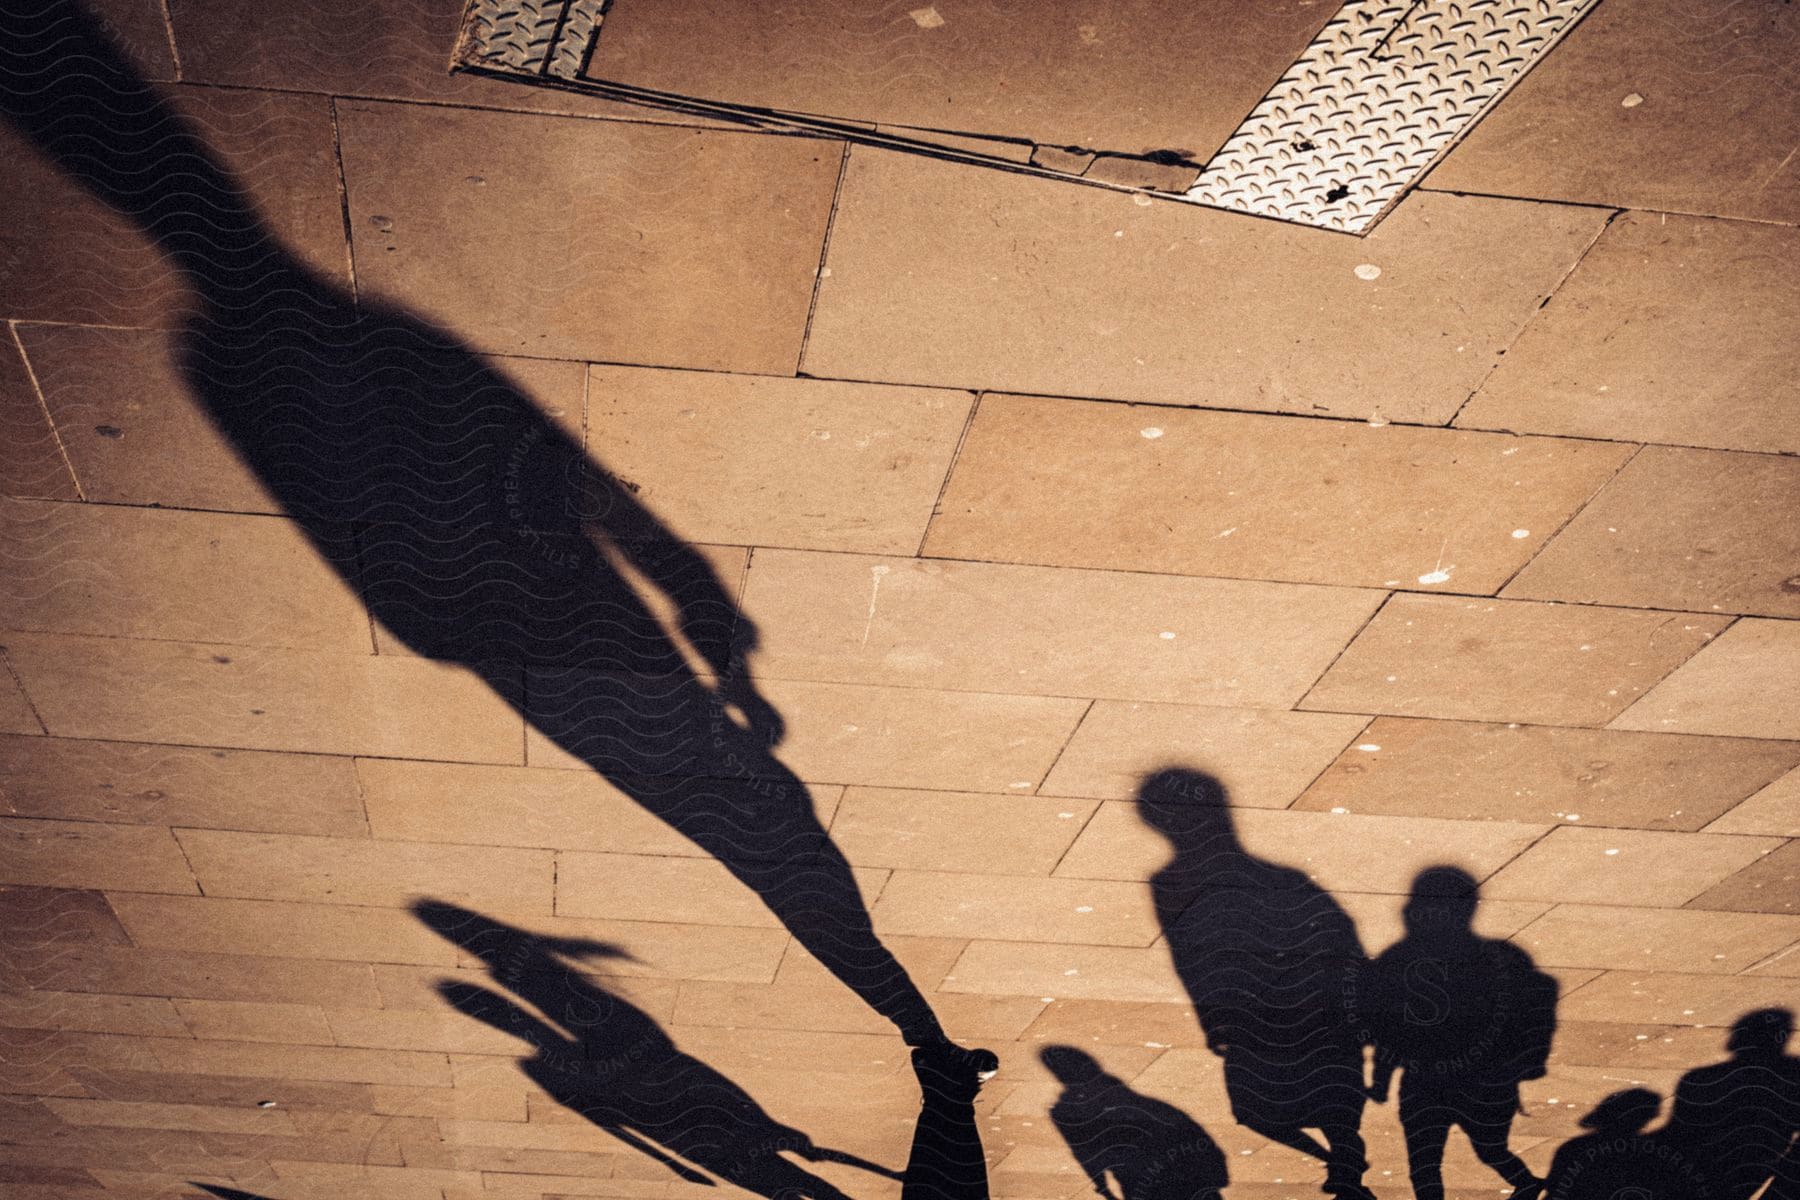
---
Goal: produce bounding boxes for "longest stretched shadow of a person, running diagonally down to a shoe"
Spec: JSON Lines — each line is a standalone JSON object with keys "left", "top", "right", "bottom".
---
{"left": 0, "top": 0, "right": 992, "bottom": 1076}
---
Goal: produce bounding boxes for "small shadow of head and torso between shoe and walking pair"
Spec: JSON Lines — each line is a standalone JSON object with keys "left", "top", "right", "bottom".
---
{"left": 1040, "top": 1045, "right": 1229, "bottom": 1200}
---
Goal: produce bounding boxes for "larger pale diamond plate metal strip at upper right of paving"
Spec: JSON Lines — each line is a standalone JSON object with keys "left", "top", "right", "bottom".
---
{"left": 1186, "top": 0, "right": 1598, "bottom": 234}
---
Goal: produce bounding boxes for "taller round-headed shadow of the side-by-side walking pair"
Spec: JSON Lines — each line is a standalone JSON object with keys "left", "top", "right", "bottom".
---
{"left": 1138, "top": 770, "right": 1370, "bottom": 1200}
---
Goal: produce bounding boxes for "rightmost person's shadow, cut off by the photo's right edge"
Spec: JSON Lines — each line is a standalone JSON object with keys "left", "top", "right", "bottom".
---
{"left": 1661, "top": 1007, "right": 1800, "bottom": 1200}
